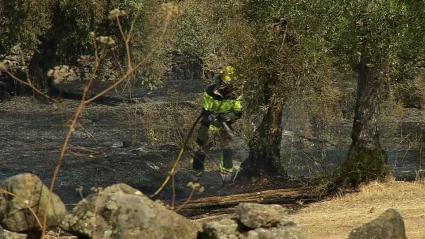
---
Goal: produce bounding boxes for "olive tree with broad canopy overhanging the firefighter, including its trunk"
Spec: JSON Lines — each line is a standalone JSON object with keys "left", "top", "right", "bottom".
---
{"left": 170, "top": 0, "right": 338, "bottom": 175}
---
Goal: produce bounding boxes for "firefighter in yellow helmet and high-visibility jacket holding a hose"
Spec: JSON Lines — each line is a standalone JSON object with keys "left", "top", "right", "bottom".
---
{"left": 192, "top": 66, "right": 242, "bottom": 183}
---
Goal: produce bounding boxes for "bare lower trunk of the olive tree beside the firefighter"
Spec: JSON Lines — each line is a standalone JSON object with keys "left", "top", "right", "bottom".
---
{"left": 243, "top": 95, "right": 286, "bottom": 176}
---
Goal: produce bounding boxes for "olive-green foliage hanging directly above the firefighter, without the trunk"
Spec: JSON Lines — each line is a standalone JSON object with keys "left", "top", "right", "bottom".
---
{"left": 173, "top": 1, "right": 338, "bottom": 108}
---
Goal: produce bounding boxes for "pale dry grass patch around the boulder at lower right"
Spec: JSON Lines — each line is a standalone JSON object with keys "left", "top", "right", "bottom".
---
{"left": 293, "top": 181, "right": 425, "bottom": 239}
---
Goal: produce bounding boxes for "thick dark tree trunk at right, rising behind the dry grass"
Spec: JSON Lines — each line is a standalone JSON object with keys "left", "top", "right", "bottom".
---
{"left": 338, "top": 57, "right": 389, "bottom": 187}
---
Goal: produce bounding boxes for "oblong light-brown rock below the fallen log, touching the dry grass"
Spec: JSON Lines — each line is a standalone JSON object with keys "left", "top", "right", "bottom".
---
{"left": 236, "top": 203, "right": 291, "bottom": 229}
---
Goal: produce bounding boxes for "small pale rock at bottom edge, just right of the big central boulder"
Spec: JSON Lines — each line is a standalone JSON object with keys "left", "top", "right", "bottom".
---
{"left": 199, "top": 218, "right": 239, "bottom": 239}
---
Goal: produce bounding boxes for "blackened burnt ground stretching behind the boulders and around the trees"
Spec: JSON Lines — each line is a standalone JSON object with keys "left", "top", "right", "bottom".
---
{"left": 0, "top": 97, "right": 423, "bottom": 214}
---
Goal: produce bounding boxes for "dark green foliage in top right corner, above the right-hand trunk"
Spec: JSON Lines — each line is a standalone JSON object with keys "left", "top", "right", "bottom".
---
{"left": 327, "top": 0, "right": 424, "bottom": 76}
